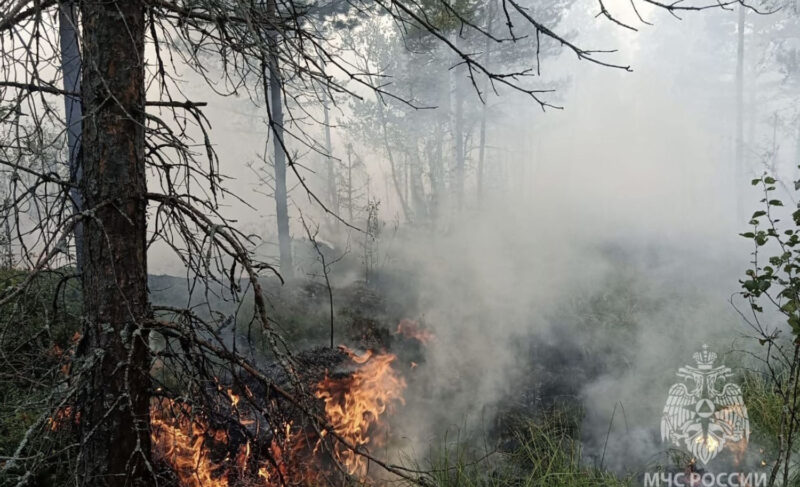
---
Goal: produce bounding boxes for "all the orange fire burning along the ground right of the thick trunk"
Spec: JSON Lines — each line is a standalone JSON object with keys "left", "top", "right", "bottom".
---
{"left": 150, "top": 348, "right": 406, "bottom": 487}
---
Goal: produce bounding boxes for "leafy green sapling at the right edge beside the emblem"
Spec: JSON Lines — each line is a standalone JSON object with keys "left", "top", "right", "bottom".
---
{"left": 740, "top": 170, "right": 800, "bottom": 485}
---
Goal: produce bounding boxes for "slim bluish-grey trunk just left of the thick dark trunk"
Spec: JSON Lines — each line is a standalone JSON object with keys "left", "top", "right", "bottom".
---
{"left": 58, "top": 0, "right": 83, "bottom": 272}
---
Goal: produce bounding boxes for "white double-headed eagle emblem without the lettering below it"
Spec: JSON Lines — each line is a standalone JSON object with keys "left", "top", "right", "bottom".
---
{"left": 661, "top": 345, "right": 750, "bottom": 464}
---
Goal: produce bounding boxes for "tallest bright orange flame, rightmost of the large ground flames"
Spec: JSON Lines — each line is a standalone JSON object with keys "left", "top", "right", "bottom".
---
{"left": 315, "top": 348, "right": 406, "bottom": 477}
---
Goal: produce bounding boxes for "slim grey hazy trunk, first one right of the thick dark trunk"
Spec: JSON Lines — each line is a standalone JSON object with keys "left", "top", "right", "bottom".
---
{"left": 267, "top": 0, "right": 294, "bottom": 279}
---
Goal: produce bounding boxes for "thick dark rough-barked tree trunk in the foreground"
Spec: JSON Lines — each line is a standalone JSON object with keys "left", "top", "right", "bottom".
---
{"left": 78, "top": 0, "right": 154, "bottom": 486}
